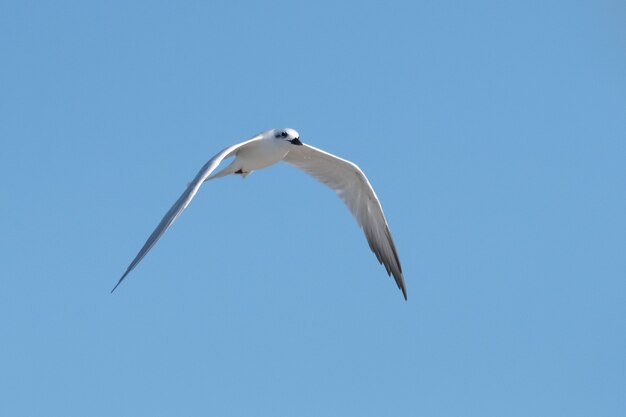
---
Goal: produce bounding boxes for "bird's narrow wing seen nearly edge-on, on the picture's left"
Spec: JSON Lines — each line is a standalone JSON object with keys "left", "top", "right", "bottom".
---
{"left": 111, "top": 136, "right": 260, "bottom": 292}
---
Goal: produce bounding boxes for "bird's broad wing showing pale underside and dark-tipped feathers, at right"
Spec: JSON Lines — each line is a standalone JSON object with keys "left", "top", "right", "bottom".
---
{"left": 284, "top": 144, "right": 407, "bottom": 300}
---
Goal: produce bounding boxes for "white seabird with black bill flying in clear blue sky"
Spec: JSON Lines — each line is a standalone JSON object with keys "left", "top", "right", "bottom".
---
{"left": 111, "top": 128, "right": 407, "bottom": 300}
